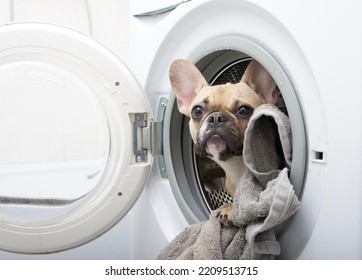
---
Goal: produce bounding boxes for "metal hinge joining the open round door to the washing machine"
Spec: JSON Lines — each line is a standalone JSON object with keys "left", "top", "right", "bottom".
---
{"left": 133, "top": 98, "right": 167, "bottom": 178}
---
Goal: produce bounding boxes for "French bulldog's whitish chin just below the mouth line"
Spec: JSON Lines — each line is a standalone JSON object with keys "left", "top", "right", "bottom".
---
{"left": 196, "top": 135, "right": 243, "bottom": 161}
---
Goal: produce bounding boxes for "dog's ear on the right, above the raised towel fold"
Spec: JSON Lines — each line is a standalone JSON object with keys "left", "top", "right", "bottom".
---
{"left": 240, "top": 59, "right": 279, "bottom": 104}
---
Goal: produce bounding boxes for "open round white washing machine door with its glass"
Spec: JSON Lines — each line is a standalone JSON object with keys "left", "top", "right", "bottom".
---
{"left": 0, "top": 23, "right": 152, "bottom": 253}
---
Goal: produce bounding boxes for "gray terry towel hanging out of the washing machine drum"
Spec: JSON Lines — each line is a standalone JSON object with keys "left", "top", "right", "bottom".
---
{"left": 158, "top": 104, "right": 299, "bottom": 260}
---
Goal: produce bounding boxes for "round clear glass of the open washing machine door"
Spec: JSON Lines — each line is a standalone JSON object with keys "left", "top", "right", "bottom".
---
{"left": 0, "top": 59, "right": 110, "bottom": 223}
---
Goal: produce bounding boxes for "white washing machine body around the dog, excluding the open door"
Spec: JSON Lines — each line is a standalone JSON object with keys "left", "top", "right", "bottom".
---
{"left": 131, "top": 0, "right": 362, "bottom": 259}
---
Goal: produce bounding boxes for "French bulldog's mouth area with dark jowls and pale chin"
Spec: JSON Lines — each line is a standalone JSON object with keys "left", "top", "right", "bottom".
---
{"left": 195, "top": 134, "right": 243, "bottom": 161}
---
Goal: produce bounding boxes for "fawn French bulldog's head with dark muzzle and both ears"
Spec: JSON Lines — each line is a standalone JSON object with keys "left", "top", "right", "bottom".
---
{"left": 170, "top": 59, "right": 278, "bottom": 161}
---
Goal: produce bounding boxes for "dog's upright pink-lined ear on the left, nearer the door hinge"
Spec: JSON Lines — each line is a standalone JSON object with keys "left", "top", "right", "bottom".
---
{"left": 170, "top": 59, "right": 208, "bottom": 116}
